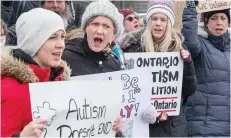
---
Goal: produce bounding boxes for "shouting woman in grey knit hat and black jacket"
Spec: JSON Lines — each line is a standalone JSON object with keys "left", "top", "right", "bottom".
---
{"left": 62, "top": 1, "right": 123, "bottom": 134}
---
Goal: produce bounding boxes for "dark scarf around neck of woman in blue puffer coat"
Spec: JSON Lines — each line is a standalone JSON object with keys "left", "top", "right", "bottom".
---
{"left": 208, "top": 31, "right": 230, "bottom": 52}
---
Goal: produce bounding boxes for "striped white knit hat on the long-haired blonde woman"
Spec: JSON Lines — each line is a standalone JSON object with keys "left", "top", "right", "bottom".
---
{"left": 147, "top": 0, "right": 175, "bottom": 26}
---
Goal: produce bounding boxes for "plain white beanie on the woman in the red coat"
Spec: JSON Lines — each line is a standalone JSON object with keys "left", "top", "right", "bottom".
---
{"left": 16, "top": 8, "right": 65, "bottom": 57}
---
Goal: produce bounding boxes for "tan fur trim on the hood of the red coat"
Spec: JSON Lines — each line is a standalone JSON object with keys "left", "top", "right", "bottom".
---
{"left": 0, "top": 46, "right": 71, "bottom": 83}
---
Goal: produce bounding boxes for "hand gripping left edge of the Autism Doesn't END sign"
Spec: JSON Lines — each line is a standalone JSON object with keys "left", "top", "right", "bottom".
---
{"left": 20, "top": 119, "right": 47, "bottom": 137}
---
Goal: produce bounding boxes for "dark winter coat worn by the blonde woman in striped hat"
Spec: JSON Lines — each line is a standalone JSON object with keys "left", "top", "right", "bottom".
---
{"left": 120, "top": 30, "right": 196, "bottom": 137}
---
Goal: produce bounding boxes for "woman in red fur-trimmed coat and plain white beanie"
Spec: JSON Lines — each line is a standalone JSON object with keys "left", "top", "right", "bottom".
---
{"left": 1, "top": 8, "right": 70, "bottom": 137}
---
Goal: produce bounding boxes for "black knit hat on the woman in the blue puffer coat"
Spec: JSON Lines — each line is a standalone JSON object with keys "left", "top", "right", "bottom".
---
{"left": 203, "top": 9, "right": 230, "bottom": 25}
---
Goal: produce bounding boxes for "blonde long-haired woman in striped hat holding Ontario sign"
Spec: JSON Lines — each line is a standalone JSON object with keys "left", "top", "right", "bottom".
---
{"left": 120, "top": 0, "right": 197, "bottom": 137}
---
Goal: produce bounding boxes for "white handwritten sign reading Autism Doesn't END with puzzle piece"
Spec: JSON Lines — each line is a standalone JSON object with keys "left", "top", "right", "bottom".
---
{"left": 29, "top": 81, "right": 122, "bottom": 137}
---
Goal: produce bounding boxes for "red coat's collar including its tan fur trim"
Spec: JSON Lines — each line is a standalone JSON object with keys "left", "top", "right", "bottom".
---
{"left": 1, "top": 47, "right": 71, "bottom": 83}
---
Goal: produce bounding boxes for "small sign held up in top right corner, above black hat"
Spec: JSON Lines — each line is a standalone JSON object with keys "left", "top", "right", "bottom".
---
{"left": 196, "top": 0, "right": 231, "bottom": 13}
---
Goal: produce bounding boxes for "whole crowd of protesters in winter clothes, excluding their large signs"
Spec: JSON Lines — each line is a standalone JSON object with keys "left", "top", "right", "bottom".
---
{"left": 1, "top": 0, "right": 230, "bottom": 137}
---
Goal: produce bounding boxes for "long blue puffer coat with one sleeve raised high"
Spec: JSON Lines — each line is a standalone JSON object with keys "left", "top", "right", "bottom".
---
{"left": 182, "top": 8, "right": 230, "bottom": 137}
